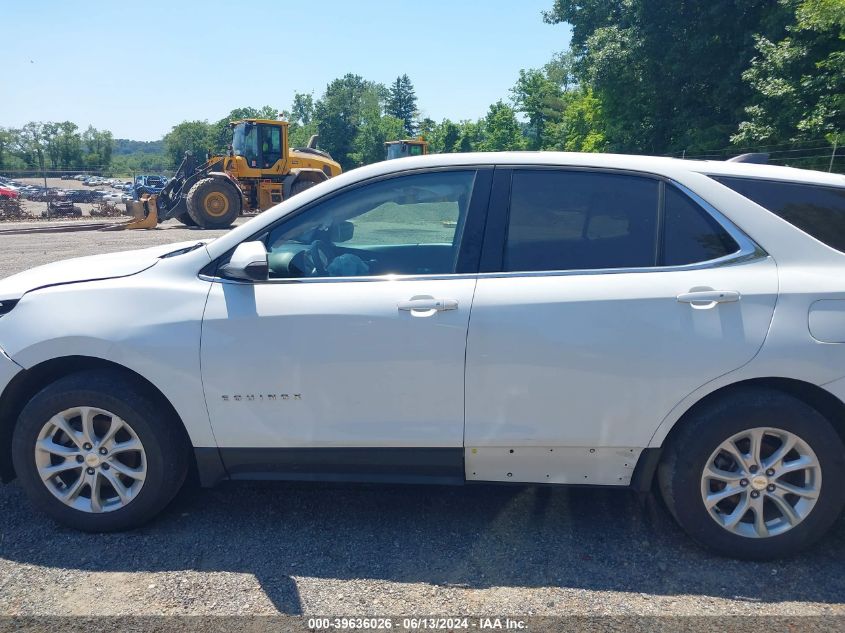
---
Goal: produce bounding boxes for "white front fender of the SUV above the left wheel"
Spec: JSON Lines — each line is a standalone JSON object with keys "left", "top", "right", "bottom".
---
{"left": 0, "top": 267, "right": 221, "bottom": 447}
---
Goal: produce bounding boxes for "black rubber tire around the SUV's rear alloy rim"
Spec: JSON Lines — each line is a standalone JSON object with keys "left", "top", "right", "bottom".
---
{"left": 658, "top": 387, "right": 845, "bottom": 560}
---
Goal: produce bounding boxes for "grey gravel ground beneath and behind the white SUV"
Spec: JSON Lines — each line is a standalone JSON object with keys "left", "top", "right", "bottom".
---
{"left": 0, "top": 217, "right": 845, "bottom": 616}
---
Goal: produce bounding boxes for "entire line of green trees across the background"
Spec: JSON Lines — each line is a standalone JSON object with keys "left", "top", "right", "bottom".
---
{"left": 0, "top": 0, "right": 845, "bottom": 175}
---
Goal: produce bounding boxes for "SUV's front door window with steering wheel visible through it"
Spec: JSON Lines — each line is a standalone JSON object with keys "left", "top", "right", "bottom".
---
{"left": 268, "top": 171, "right": 475, "bottom": 277}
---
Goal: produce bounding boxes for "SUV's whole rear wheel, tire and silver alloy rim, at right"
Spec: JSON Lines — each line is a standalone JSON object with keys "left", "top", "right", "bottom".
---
{"left": 658, "top": 388, "right": 845, "bottom": 560}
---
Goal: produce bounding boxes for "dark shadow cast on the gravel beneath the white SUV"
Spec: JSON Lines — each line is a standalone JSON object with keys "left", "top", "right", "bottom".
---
{"left": 0, "top": 482, "right": 845, "bottom": 614}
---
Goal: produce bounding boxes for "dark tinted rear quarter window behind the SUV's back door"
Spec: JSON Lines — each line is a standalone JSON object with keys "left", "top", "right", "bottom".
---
{"left": 711, "top": 176, "right": 845, "bottom": 252}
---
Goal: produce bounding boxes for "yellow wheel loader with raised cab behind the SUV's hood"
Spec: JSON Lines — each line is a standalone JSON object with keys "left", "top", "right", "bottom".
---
{"left": 121, "top": 119, "right": 341, "bottom": 229}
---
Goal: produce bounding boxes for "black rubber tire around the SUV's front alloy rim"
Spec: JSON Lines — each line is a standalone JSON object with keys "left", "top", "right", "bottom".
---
{"left": 12, "top": 370, "right": 189, "bottom": 532}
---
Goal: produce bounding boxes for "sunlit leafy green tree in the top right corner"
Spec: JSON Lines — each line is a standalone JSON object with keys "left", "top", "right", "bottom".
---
{"left": 733, "top": 0, "right": 845, "bottom": 143}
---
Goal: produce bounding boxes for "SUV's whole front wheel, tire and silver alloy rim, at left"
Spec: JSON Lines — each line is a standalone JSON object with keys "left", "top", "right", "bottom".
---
{"left": 12, "top": 371, "right": 188, "bottom": 532}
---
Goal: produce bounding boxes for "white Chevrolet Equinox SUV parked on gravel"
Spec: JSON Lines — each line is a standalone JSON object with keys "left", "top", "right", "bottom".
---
{"left": 0, "top": 153, "right": 845, "bottom": 559}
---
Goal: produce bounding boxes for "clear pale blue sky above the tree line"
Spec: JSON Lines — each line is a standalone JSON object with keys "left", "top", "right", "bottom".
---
{"left": 0, "top": 0, "right": 569, "bottom": 140}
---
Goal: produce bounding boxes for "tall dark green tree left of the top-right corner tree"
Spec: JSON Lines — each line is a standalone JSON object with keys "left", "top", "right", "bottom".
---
{"left": 545, "top": 0, "right": 788, "bottom": 154}
